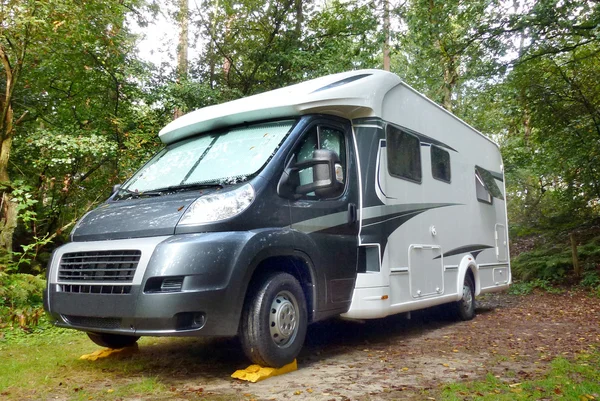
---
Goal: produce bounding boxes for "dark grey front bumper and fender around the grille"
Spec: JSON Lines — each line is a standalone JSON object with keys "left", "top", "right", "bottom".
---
{"left": 46, "top": 229, "right": 294, "bottom": 336}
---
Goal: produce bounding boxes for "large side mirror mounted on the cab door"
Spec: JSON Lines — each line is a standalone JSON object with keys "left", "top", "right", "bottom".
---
{"left": 277, "top": 149, "right": 344, "bottom": 199}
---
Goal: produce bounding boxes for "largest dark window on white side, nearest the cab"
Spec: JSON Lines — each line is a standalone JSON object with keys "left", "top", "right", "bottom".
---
{"left": 386, "top": 125, "right": 422, "bottom": 183}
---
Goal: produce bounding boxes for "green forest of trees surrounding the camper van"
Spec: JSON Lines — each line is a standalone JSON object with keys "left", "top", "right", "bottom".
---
{"left": 0, "top": 0, "right": 600, "bottom": 328}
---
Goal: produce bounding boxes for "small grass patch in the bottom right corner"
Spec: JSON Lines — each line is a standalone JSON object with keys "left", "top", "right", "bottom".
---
{"left": 439, "top": 352, "right": 600, "bottom": 401}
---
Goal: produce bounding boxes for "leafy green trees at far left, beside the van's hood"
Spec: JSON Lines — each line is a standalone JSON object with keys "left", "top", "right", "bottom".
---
{"left": 0, "top": 0, "right": 149, "bottom": 269}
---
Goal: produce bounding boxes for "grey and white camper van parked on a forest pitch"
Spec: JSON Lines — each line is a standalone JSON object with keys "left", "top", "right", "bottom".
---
{"left": 45, "top": 70, "right": 511, "bottom": 367}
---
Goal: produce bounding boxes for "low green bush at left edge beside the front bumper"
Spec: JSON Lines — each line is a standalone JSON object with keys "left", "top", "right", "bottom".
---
{"left": 0, "top": 272, "right": 46, "bottom": 328}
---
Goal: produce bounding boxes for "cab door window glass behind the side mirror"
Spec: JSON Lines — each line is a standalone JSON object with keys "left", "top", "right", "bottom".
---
{"left": 296, "top": 126, "right": 346, "bottom": 196}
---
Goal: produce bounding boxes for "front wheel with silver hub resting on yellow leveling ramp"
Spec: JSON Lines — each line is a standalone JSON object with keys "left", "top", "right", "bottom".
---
{"left": 240, "top": 273, "right": 308, "bottom": 368}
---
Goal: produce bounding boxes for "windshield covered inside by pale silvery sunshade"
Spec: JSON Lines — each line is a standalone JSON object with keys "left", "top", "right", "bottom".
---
{"left": 122, "top": 120, "right": 295, "bottom": 193}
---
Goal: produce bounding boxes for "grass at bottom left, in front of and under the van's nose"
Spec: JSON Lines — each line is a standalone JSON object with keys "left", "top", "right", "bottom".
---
{"left": 0, "top": 328, "right": 245, "bottom": 401}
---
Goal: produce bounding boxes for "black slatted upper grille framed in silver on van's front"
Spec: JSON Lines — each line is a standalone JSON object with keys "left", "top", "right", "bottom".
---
{"left": 58, "top": 250, "right": 142, "bottom": 282}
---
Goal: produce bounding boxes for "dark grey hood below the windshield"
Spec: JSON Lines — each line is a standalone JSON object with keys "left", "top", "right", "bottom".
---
{"left": 72, "top": 191, "right": 204, "bottom": 241}
